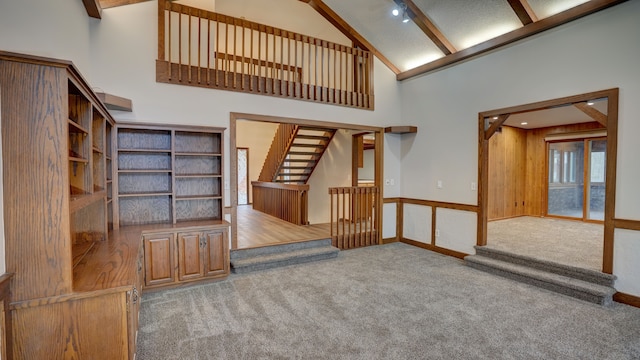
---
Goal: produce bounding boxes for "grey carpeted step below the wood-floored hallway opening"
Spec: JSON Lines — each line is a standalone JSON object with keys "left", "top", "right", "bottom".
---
{"left": 231, "top": 239, "right": 340, "bottom": 274}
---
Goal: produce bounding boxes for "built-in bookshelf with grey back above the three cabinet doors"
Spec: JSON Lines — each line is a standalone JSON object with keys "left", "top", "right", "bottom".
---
{"left": 117, "top": 124, "right": 224, "bottom": 226}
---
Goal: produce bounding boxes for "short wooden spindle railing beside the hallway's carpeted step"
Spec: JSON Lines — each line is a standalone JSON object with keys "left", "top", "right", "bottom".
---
{"left": 329, "top": 186, "right": 381, "bottom": 249}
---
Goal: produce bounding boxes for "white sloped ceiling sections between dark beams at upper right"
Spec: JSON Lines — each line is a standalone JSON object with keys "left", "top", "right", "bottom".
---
{"left": 323, "top": 0, "right": 608, "bottom": 72}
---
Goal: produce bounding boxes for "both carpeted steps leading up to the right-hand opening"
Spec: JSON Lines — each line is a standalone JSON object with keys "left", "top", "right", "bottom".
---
{"left": 464, "top": 246, "right": 616, "bottom": 306}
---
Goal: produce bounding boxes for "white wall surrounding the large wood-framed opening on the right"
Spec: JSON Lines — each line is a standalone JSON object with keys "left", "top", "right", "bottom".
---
{"left": 401, "top": 1, "right": 640, "bottom": 296}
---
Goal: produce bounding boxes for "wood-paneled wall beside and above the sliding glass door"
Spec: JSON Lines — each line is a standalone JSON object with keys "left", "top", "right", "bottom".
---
{"left": 487, "top": 122, "right": 603, "bottom": 220}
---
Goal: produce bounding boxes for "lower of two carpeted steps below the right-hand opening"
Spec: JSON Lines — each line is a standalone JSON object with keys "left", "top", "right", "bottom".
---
{"left": 464, "top": 255, "right": 616, "bottom": 305}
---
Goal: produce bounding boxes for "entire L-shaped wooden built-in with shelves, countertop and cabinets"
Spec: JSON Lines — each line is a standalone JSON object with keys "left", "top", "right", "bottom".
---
{"left": 0, "top": 51, "right": 229, "bottom": 359}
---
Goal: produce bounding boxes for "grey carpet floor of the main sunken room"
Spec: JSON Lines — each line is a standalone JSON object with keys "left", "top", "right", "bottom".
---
{"left": 138, "top": 243, "right": 640, "bottom": 360}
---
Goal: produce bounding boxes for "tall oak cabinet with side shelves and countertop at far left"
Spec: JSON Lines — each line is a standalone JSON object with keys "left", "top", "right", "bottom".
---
{"left": 0, "top": 52, "right": 142, "bottom": 359}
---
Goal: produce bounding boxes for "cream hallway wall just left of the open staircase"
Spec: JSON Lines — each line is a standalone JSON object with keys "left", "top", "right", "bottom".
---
{"left": 234, "top": 120, "right": 278, "bottom": 203}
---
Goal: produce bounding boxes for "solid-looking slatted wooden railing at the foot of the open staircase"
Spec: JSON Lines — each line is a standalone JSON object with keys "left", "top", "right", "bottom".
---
{"left": 251, "top": 181, "right": 309, "bottom": 225}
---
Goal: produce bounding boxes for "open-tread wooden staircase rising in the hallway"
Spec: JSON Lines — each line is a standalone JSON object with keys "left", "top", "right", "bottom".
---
{"left": 271, "top": 126, "right": 336, "bottom": 184}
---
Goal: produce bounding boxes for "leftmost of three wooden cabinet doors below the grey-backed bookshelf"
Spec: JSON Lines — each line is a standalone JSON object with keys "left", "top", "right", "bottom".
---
{"left": 144, "top": 233, "right": 175, "bottom": 286}
